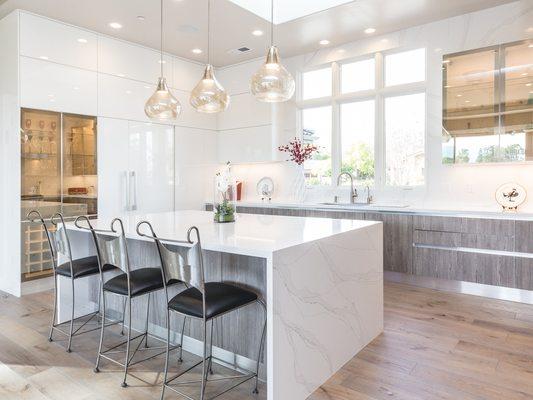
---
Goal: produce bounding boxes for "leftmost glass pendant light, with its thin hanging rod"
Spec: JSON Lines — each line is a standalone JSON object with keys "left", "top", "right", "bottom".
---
{"left": 144, "top": 0, "right": 181, "bottom": 122}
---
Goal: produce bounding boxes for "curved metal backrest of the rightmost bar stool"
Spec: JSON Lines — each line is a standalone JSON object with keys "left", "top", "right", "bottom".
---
{"left": 137, "top": 221, "right": 205, "bottom": 294}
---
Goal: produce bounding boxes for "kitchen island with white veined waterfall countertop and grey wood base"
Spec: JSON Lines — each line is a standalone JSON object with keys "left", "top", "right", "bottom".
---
{"left": 59, "top": 211, "right": 383, "bottom": 400}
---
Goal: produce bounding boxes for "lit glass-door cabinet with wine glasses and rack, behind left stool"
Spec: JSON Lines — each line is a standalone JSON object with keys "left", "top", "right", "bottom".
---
{"left": 20, "top": 108, "right": 98, "bottom": 282}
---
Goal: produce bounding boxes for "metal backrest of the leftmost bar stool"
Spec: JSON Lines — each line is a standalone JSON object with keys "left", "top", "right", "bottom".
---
{"left": 27, "top": 210, "right": 74, "bottom": 276}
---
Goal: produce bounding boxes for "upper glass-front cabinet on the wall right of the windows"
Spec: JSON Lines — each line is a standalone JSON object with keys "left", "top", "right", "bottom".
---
{"left": 442, "top": 41, "right": 533, "bottom": 164}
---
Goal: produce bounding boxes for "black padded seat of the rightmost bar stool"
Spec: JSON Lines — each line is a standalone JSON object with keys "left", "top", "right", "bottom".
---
{"left": 168, "top": 282, "right": 257, "bottom": 319}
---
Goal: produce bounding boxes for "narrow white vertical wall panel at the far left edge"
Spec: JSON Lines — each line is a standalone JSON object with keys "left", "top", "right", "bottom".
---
{"left": 0, "top": 13, "right": 21, "bottom": 296}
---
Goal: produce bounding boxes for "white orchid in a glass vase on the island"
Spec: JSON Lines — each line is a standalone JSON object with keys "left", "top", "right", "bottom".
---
{"left": 213, "top": 162, "right": 237, "bottom": 222}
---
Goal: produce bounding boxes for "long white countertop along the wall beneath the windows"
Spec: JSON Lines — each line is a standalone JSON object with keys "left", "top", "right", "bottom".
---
{"left": 213, "top": 201, "right": 533, "bottom": 221}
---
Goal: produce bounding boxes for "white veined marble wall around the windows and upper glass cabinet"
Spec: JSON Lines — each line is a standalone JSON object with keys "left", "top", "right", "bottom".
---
{"left": 214, "top": 0, "right": 533, "bottom": 211}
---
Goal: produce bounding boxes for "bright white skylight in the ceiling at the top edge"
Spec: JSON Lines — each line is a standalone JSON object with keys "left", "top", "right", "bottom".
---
{"left": 225, "top": 0, "right": 352, "bottom": 24}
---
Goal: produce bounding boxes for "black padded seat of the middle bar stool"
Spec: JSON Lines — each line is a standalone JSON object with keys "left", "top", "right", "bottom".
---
{"left": 104, "top": 268, "right": 164, "bottom": 297}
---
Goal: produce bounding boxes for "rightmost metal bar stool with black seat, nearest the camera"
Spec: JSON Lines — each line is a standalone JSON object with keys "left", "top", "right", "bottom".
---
{"left": 137, "top": 221, "right": 267, "bottom": 400}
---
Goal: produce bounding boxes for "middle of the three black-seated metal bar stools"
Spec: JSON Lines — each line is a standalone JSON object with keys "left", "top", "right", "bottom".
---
{"left": 76, "top": 218, "right": 181, "bottom": 387}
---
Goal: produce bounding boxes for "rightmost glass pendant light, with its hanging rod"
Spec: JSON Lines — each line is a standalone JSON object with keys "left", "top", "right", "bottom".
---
{"left": 250, "top": 0, "right": 295, "bottom": 103}
